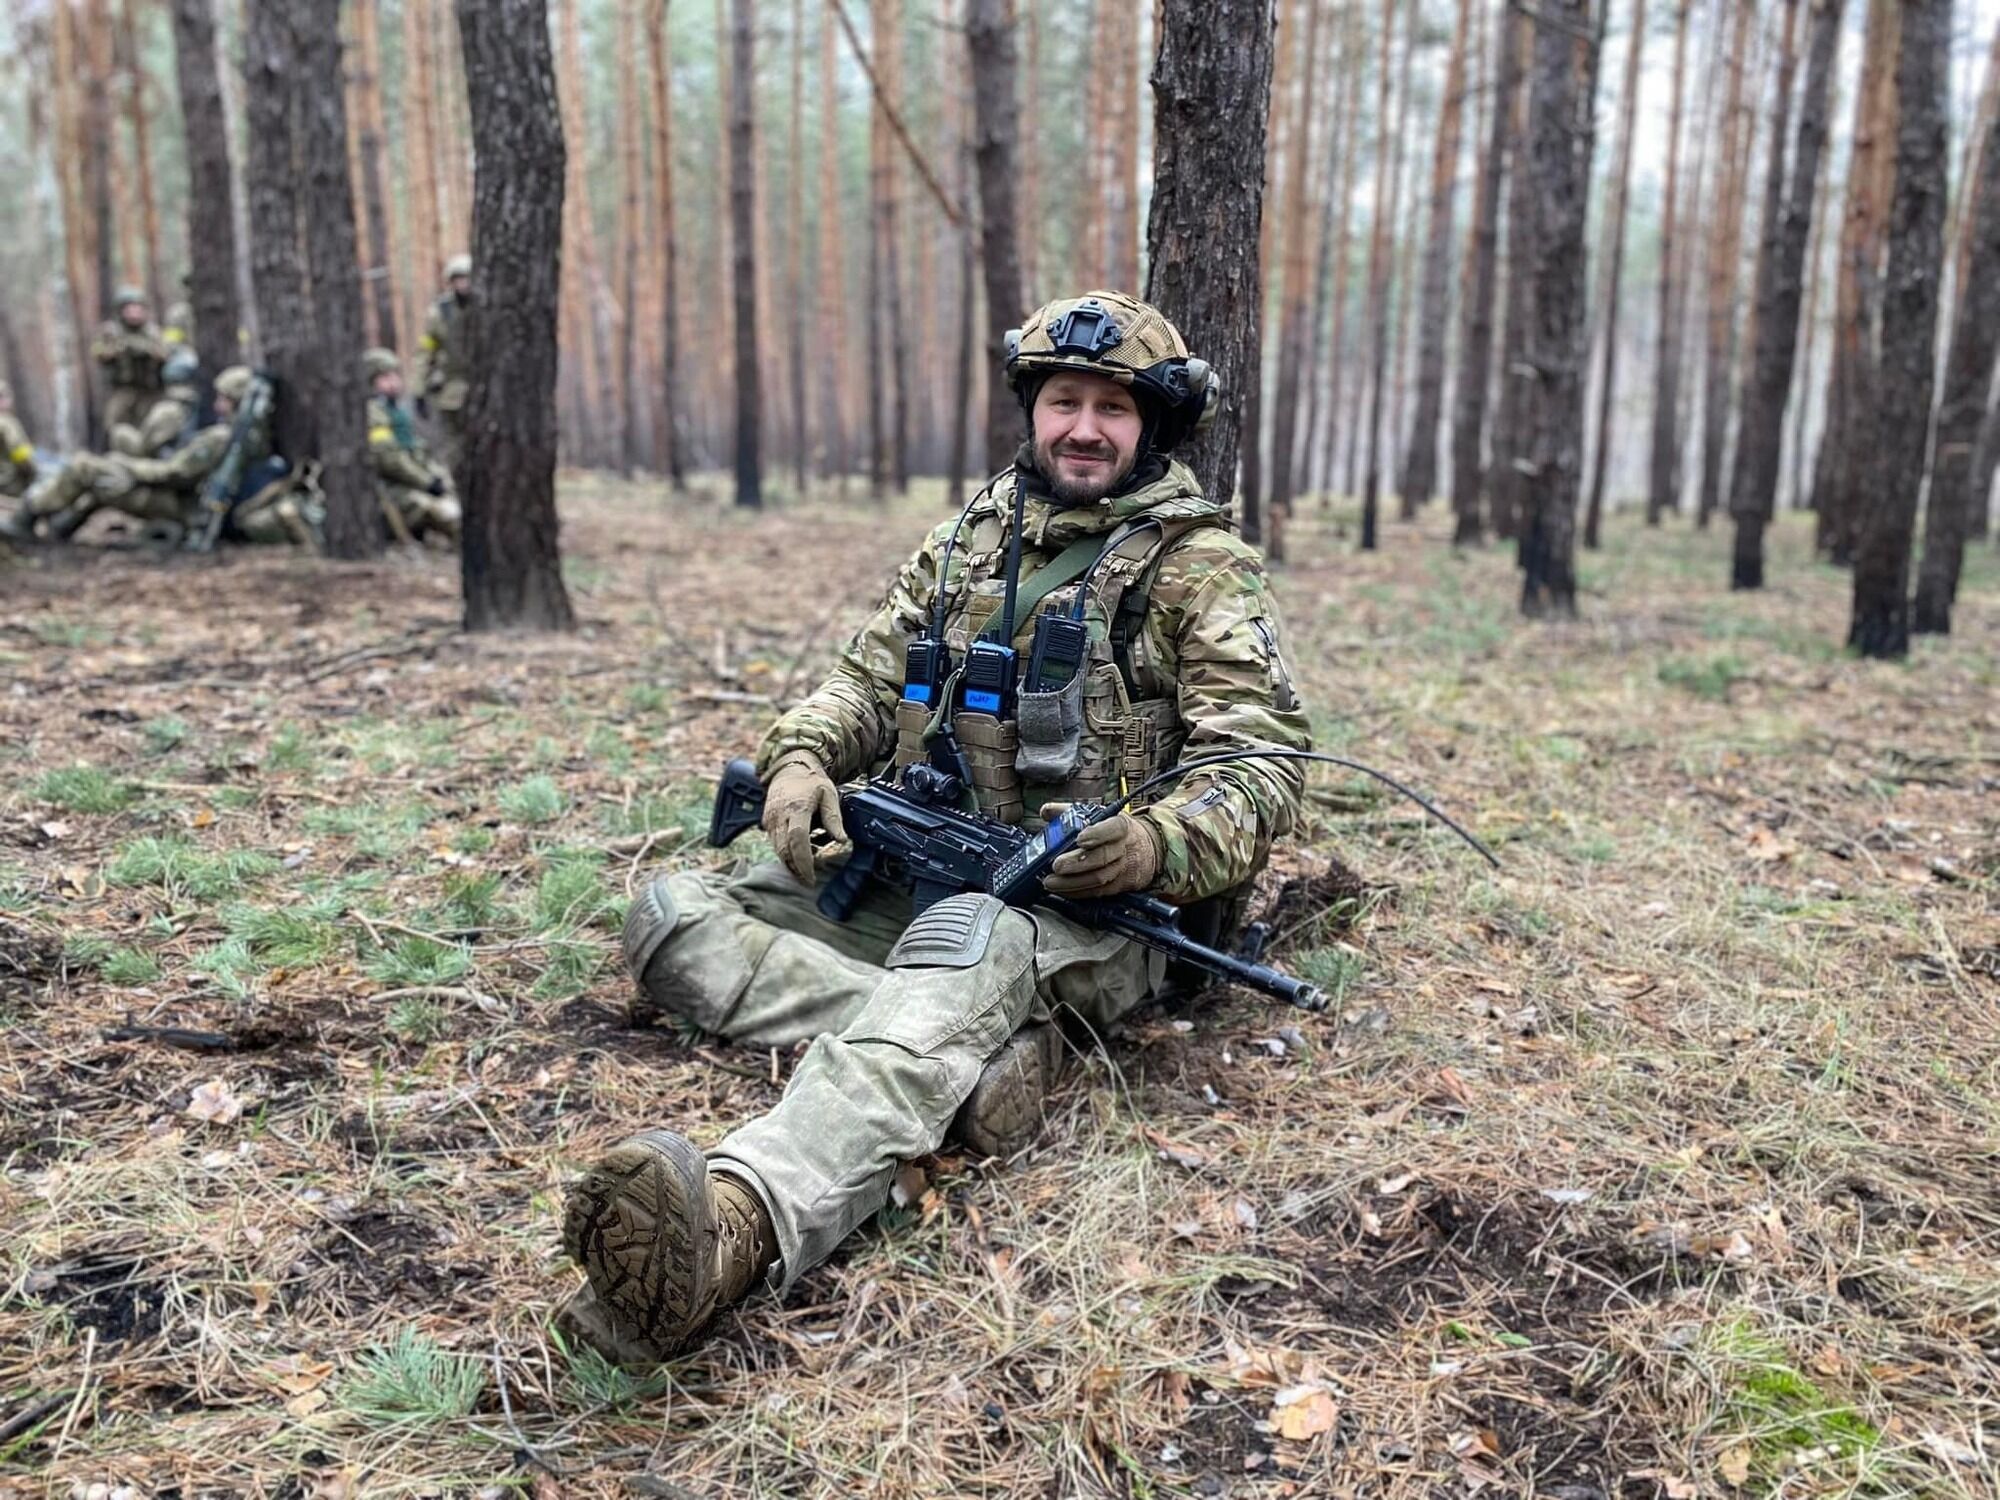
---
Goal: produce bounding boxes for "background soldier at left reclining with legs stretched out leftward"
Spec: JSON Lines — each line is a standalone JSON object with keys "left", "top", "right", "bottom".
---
{"left": 16, "top": 364, "right": 270, "bottom": 542}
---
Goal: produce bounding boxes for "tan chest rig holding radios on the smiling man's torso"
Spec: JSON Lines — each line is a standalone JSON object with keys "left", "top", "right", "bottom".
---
{"left": 896, "top": 478, "right": 1220, "bottom": 826}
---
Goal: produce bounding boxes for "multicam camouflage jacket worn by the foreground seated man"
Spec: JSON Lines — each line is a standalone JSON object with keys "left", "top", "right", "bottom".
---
{"left": 758, "top": 464, "right": 1312, "bottom": 902}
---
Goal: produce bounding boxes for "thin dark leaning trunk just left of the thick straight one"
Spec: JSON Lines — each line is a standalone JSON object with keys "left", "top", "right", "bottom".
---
{"left": 1452, "top": 0, "right": 1522, "bottom": 546}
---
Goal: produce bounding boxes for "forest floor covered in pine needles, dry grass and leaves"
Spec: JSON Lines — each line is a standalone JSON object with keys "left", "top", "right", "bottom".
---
{"left": 0, "top": 480, "right": 2000, "bottom": 1500}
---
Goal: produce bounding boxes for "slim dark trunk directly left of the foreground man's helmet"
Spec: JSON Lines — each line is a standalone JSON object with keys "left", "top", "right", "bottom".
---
{"left": 966, "top": 0, "right": 1032, "bottom": 470}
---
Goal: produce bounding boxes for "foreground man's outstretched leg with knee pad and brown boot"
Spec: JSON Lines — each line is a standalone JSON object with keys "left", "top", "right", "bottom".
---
{"left": 564, "top": 890, "right": 1160, "bottom": 1358}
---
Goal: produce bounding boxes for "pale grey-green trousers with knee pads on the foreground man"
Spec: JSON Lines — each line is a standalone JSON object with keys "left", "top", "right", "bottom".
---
{"left": 624, "top": 864, "right": 1164, "bottom": 1292}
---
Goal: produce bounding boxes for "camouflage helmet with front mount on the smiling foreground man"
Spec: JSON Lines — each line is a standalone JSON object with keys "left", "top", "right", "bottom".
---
{"left": 1006, "top": 292, "right": 1222, "bottom": 454}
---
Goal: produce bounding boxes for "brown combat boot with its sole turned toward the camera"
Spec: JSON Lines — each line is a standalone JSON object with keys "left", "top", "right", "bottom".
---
{"left": 560, "top": 1130, "right": 778, "bottom": 1364}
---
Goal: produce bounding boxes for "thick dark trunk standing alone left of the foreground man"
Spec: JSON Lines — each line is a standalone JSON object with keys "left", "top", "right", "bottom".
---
{"left": 458, "top": 0, "right": 576, "bottom": 630}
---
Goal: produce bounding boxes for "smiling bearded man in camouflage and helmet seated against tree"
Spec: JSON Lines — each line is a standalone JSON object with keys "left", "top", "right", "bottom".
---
{"left": 560, "top": 292, "right": 1310, "bottom": 1362}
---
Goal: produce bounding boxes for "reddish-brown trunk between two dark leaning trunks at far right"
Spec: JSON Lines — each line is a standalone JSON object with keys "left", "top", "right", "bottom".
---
{"left": 1812, "top": 0, "right": 1900, "bottom": 564}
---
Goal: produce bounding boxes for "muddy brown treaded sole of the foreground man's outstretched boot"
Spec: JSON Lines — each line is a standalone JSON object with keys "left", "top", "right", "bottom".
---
{"left": 562, "top": 1130, "right": 718, "bottom": 1358}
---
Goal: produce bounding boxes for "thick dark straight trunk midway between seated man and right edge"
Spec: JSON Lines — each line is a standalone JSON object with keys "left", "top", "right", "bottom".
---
{"left": 1520, "top": 0, "right": 1598, "bottom": 616}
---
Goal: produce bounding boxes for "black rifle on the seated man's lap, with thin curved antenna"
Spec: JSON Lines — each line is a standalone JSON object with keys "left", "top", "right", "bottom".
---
{"left": 708, "top": 750, "right": 1500, "bottom": 1010}
